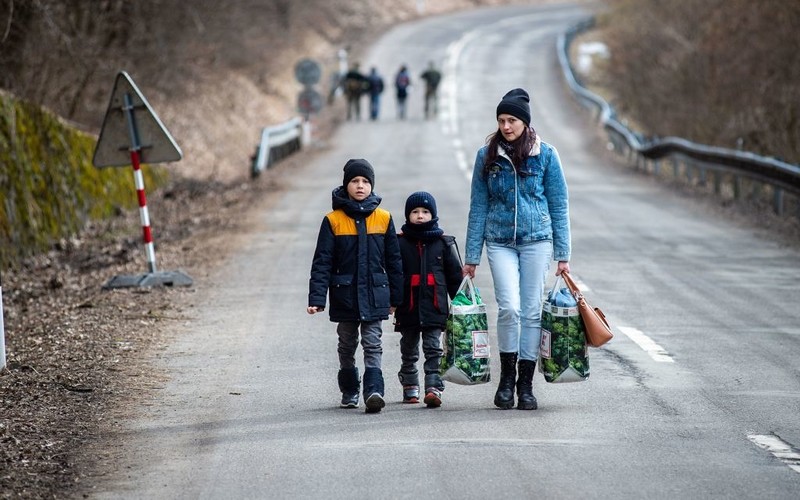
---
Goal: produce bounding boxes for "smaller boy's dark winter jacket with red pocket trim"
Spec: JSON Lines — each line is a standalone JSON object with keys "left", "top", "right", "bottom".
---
{"left": 394, "top": 234, "right": 462, "bottom": 331}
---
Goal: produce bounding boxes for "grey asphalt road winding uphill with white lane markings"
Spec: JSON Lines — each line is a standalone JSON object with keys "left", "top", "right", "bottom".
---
{"left": 93, "top": 1, "right": 800, "bottom": 499}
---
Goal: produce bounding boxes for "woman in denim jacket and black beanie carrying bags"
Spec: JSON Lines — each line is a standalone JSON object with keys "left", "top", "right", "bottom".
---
{"left": 463, "top": 89, "right": 571, "bottom": 410}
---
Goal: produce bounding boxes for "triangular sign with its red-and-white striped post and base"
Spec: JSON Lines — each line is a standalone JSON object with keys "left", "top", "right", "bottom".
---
{"left": 92, "top": 71, "right": 192, "bottom": 288}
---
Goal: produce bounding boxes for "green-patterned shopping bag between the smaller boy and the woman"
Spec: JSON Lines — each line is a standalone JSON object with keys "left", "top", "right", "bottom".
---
{"left": 439, "top": 276, "right": 490, "bottom": 385}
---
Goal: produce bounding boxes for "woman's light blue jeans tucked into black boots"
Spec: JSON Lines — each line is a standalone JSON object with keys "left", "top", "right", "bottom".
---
{"left": 486, "top": 240, "right": 553, "bottom": 361}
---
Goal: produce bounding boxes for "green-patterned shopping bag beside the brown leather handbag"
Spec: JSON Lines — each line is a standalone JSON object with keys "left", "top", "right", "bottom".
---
{"left": 539, "top": 277, "right": 589, "bottom": 383}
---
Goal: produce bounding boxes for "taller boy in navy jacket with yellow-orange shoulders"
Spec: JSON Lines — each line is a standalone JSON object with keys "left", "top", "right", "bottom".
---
{"left": 307, "top": 159, "right": 403, "bottom": 413}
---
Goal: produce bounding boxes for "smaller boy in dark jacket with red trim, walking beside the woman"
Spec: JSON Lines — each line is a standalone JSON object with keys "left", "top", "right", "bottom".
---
{"left": 394, "top": 191, "right": 462, "bottom": 408}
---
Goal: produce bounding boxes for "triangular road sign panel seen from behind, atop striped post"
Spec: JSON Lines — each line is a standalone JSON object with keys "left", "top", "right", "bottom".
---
{"left": 92, "top": 71, "right": 183, "bottom": 167}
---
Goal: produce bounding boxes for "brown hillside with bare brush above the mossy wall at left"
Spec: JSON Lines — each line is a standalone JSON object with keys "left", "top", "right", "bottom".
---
{"left": 0, "top": 0, "right": 532, "bottom": 181}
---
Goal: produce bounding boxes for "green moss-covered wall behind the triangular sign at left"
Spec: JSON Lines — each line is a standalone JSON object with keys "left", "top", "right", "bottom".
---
{"left": 0, "top": 92, "right": 168, "bottom": 269}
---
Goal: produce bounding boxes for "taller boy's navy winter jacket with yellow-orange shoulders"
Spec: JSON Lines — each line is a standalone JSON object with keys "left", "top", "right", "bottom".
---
{"left": 308, "top": 187, "right": 403, "bottom": 323}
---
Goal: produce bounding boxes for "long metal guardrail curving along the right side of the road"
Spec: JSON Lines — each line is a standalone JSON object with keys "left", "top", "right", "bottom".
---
{"left": 558, "top": 18, "right": 800, "bottom": 217}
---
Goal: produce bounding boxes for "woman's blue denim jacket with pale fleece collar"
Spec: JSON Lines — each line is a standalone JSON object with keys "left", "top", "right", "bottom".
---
{"left": 464, "top": 137, "right": 571, "bottom": 265}
